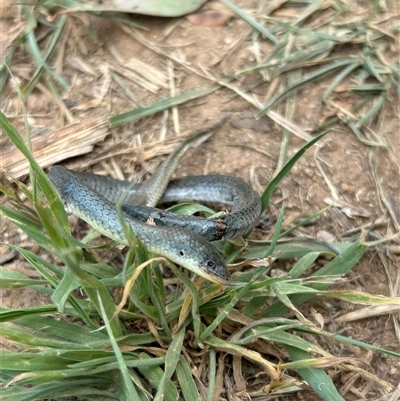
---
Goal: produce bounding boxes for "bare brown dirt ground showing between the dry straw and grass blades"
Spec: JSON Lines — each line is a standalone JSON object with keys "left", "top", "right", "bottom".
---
{"left": 0, "top": 0, "right": 400, "bottom": 401}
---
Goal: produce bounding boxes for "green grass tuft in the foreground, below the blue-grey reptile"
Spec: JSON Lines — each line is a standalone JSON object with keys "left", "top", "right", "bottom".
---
{"left": 0, "top": 114, "right": 400, "bottom": 400}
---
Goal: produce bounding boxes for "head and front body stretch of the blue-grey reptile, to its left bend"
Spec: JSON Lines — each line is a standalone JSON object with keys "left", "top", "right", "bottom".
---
{"left": 48, "top": 166, "right": 231, "bottom": 284}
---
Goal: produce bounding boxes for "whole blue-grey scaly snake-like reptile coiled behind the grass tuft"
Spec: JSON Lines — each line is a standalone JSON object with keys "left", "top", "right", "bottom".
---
{"left": 48, "top": 123, "right": 261, "bottom": 284}
